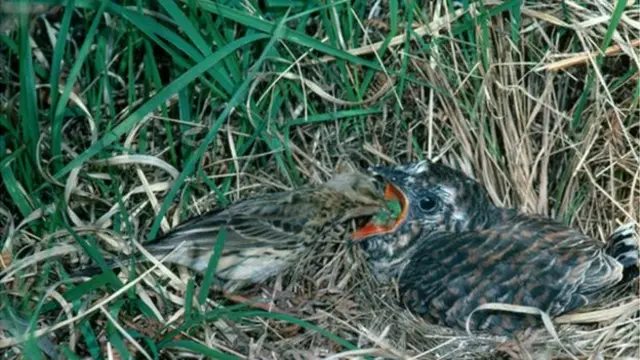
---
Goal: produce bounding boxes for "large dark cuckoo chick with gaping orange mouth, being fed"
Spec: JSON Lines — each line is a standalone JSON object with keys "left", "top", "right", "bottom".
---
{"left": 353, "top": 161, "right": 638, "bottom": 335}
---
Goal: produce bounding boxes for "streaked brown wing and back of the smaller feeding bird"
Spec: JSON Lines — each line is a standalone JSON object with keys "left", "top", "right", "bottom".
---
{"left": 147, "top": 187, "right": 378, "bottom": 254}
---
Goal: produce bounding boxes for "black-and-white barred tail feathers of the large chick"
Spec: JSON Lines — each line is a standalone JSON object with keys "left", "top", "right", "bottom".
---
{"left": 606, "top": 222, "right": 640, "bottom": 276}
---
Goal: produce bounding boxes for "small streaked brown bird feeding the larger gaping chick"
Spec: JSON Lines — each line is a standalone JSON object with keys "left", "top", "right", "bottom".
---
{"left": 75, "top": 171, "right": 385, "bottom": 290}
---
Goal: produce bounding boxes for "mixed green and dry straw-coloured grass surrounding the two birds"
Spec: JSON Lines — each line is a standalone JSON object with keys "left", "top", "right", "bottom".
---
{"left": 0, "top": 0, "right": 640, "bottom": 359}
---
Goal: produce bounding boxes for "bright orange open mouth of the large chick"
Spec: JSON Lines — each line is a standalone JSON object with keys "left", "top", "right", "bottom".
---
{"left": 351, "top": 183, "right": 409, "bottom": 241}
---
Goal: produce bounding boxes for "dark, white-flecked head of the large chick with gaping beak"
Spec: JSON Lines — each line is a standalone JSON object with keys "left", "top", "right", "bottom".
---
{"left": 352, "top": 160, "right": 497, "bottom": 278}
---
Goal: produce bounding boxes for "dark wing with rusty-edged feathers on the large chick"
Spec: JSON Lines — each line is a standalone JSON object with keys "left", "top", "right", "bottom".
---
{"left": 400, "top": 224, "right": 612, "bottom": 332}
